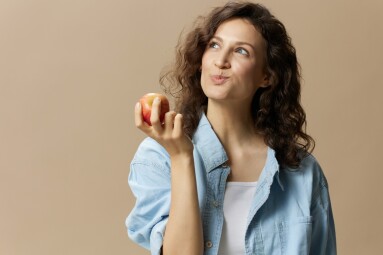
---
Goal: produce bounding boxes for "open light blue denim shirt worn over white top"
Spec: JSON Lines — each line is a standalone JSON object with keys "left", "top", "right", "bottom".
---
{"left": 126, "top": 115, "right": 336, "bottom": 255}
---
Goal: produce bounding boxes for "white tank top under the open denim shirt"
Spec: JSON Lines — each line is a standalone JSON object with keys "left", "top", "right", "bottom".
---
{"left": 218, "top": 182, "right": 257, "bottom": 255}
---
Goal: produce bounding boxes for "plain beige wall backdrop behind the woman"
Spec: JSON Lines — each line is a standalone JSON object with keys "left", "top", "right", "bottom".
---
{"left": 0, "top": 0, "right": 383, "bottom": 255}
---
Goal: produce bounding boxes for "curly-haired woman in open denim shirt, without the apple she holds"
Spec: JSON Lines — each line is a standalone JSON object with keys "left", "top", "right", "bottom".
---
{"left": 126, "top": 2, "right": 336, "bottom": 255}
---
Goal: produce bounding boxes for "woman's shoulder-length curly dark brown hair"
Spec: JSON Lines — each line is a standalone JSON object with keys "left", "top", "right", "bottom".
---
{"left": 160, "top": 2, "right": 315, "bottom": 168}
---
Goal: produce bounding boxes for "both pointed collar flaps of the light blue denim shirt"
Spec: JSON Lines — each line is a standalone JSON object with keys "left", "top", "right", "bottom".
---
{"left": 192, "top": 113, "right": 284, "bottom": 190}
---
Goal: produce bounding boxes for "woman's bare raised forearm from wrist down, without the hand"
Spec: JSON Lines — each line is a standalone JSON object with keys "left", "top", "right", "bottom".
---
{"left": 163, "top": 155, "right": 203, "bottom": 255}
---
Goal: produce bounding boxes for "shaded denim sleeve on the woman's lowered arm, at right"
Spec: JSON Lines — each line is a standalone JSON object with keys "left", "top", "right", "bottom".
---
{"left": 310, "top": 169, "right": 337, "bottom": 255}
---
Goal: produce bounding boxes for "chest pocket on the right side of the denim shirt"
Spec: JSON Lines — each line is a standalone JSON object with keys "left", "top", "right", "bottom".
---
{"left": 276, "top": 216, "right": 312, "bottom": 255}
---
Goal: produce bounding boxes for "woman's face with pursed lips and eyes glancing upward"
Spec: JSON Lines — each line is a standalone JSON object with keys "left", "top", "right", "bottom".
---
{"left": 201, "top": 18, "right": 268, "bottom": 103}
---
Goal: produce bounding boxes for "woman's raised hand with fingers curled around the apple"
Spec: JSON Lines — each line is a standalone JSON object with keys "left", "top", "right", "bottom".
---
{"left": 135, "top": 97, "right": 193, "bottom": 157}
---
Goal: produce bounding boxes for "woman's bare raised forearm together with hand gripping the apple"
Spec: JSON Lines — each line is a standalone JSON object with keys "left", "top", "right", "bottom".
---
{"left": 135, "top": 98, "right": 203, "bottom": 255}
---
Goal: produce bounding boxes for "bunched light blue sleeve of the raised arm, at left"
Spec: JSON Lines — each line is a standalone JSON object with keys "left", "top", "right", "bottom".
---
{"left": 126, "top": 141, "right": 171, "bottom": 255}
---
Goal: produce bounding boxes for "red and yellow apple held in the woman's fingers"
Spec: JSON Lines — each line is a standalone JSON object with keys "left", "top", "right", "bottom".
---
{"left": 140, "top": 93, "right": 169, "bottom": 125}
